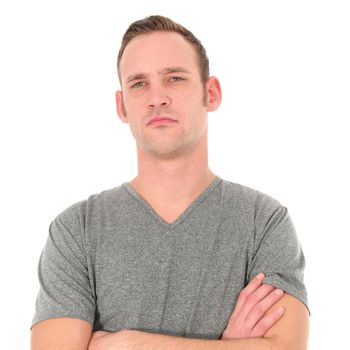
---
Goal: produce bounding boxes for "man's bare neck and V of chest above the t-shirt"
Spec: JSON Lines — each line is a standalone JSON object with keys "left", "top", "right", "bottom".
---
{"left": 131, "top": 143, "right": 215, "bottom": 221}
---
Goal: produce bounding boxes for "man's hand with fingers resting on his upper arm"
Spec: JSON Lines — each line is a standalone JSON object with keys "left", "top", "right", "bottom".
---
{"left": 221, "top": 273, "right": 284, "bottom": 339}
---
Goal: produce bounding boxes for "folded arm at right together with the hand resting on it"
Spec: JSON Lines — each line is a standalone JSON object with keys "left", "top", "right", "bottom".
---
{"left": 89, "top": 278, "right": 309, "bottom": 350}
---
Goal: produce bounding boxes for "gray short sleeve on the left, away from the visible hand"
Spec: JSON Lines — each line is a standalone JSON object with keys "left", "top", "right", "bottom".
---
{"left": 32, "top": 202, "right": 95, "bottom": 326}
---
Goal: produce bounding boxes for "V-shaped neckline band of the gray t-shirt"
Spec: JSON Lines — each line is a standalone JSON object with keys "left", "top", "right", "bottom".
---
{"left": 122, "top": 176, "right": 222, "bottom": 230}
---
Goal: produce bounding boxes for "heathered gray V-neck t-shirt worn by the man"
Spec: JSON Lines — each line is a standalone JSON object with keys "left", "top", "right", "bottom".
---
{"left": 32, "top": 177, "right": 307, "bottom": 339}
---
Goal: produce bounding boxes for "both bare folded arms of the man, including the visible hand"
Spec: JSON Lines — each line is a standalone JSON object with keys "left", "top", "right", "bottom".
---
{"left": 31, "top": 274, "right": 309, "bottom": 350}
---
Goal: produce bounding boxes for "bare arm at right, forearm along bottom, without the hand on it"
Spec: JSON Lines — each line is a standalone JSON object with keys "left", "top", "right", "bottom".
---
{"left": 89, "top": 294, "right": 309, "bottom": 350}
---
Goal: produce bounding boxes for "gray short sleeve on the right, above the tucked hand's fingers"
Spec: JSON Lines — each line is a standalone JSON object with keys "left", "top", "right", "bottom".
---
{"left": 249, "top": 197, "right": 308, "bottom": 314}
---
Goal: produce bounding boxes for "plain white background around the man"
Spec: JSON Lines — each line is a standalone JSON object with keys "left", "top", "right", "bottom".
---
{"left": 0, "top": 0, "right": 350, "bottom": 350}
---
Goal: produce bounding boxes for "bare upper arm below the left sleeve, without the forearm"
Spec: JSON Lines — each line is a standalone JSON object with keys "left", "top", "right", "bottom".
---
{"left": 31, "top": 318, "right": 92, "bottom": 350}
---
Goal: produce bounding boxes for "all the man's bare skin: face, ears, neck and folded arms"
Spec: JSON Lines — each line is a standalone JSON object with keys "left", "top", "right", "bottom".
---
{"left": 32, "top": 32, "right": 308, "bottom": 350}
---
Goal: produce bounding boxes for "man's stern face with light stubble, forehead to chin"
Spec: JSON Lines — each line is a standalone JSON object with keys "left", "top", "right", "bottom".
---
{"left": 117, "top": 32, "right": 208, "bottom": 158}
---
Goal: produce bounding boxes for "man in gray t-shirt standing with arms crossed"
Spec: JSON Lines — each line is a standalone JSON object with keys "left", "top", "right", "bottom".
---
{"left": 32, "top": 16, "right": 308, "bottom": 350}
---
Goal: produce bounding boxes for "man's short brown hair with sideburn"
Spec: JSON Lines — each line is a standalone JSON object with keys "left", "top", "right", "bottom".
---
{"left": 117, "top": 16, "right": 209, "bottom": 83}
